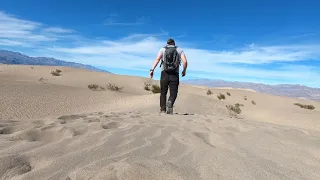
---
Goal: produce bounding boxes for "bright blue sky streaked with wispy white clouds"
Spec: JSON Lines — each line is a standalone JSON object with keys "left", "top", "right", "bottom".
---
{"left": 0, "top": 0, "right": 320, "bottom": 87}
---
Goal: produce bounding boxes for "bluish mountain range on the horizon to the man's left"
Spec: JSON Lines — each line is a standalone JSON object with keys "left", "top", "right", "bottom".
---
{"left": 0, "top": 50, "right": 110, "bottom": 73}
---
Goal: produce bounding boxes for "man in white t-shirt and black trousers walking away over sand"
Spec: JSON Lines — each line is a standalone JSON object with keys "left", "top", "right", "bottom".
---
{"left": 150, "top": 39, "right": 188, "bottom": 114}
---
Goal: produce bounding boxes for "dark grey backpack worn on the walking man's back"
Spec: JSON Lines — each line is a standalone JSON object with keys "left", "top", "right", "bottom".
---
{"left": 162, "top": 46, "right": 180, "bottom": 72}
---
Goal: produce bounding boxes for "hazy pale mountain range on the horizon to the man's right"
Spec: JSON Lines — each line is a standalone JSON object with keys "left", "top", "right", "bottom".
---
{"left": 182, "top": 79, "right": 320, "bottom": 101}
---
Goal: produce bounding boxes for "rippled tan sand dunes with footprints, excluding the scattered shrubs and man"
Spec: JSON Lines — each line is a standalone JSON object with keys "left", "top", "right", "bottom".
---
{"left": 0, "top": 65, "right": 320, "bottom": 180}
